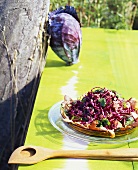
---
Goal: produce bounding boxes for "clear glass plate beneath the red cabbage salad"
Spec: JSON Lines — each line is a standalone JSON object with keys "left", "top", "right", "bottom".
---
{"left": 48, "top": 102, "right": 138, "bottom": 144}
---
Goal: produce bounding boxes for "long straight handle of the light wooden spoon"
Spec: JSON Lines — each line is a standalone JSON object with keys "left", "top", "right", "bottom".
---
{"left": 51, "top": 148, "right": 138, "bottom": 159}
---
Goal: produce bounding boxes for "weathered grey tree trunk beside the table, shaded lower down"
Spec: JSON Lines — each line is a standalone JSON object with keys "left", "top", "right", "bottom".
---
{"left": 0, "top": 0, "right": 50, "bottom": 170}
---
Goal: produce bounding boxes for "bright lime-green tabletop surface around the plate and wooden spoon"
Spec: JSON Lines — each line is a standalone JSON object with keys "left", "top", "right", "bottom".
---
{"left": 19, "top": 28, "right": 138, "bottom": 170}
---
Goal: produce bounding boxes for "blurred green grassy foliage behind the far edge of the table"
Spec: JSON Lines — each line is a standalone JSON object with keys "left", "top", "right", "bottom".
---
{"left": 50, "top": 0, "right": 138, "bottom": 30}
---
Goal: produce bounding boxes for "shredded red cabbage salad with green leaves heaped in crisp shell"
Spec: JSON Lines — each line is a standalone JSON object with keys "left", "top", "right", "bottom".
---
{"left": 61, "top": 87, "right": 138, "bottom": 135}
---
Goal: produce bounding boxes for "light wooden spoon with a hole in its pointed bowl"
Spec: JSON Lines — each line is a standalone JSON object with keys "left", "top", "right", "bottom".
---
{"left": 8, "top": 146, "right": 138, "bottom": 164}
